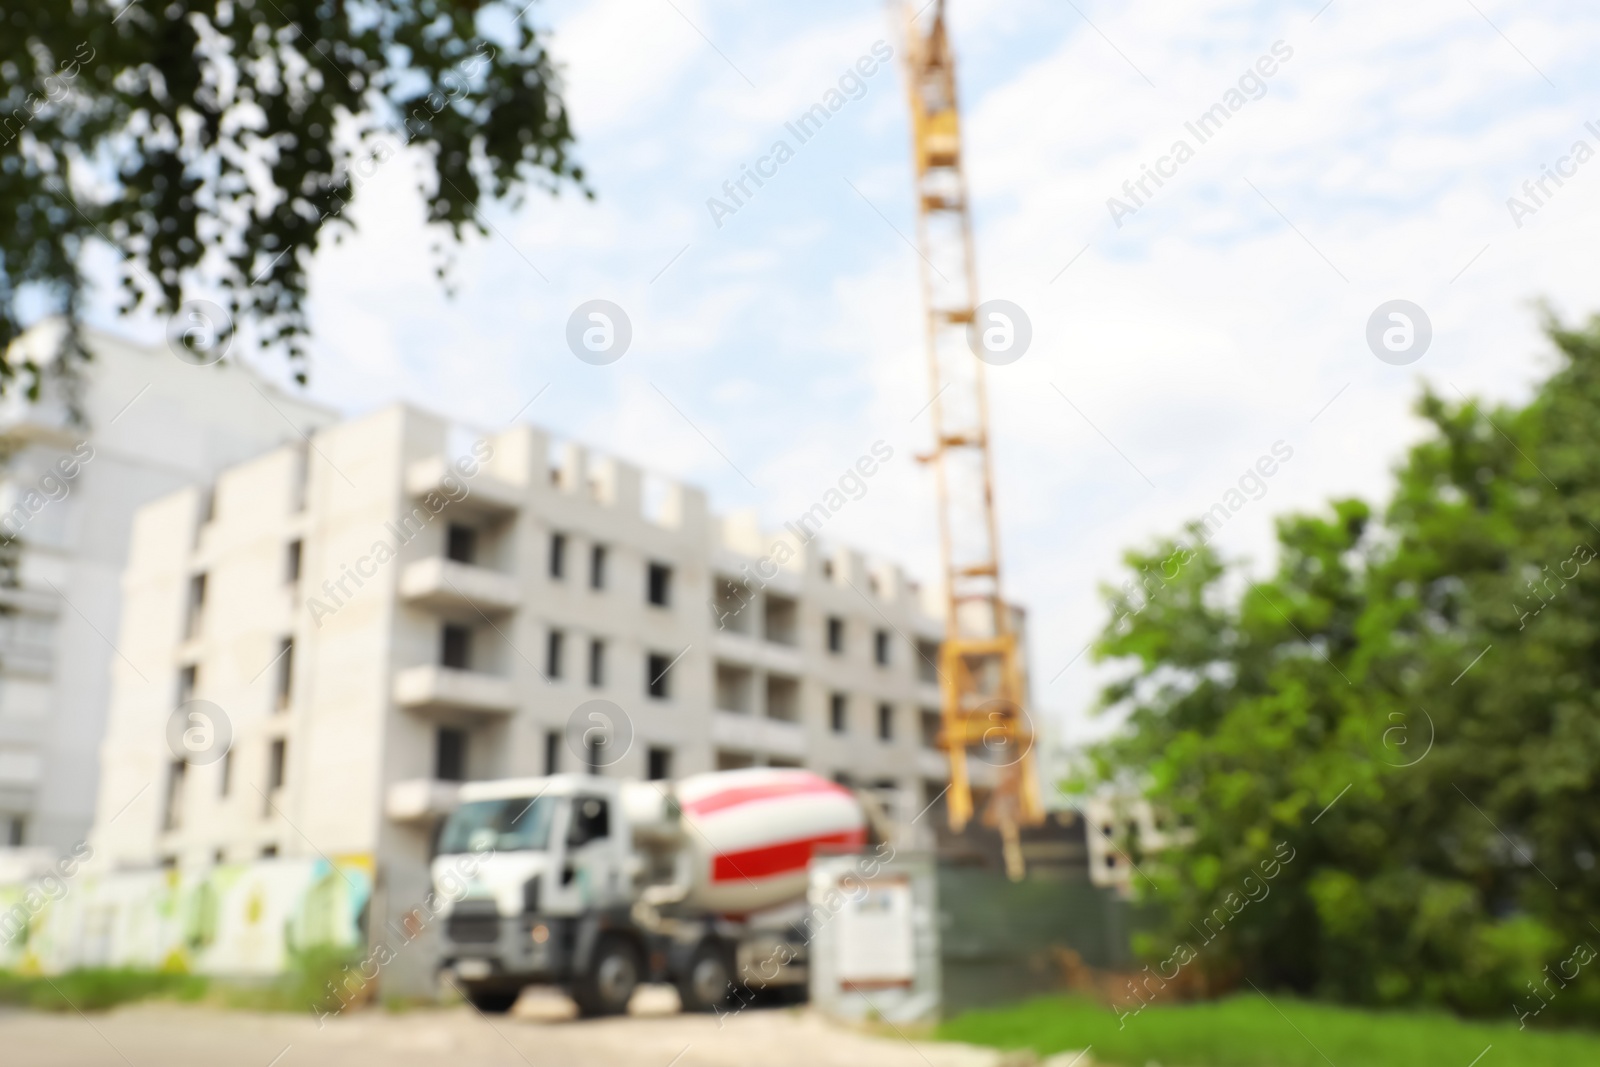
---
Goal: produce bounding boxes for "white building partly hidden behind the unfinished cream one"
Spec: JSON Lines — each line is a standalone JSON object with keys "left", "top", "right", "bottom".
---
{"left": 0, "top": 325, "right": 338, "bottom": 862}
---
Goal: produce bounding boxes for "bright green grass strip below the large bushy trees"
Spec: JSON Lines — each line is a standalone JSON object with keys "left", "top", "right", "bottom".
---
{"left": 938, "top": 993, "right": 1600, "bottom": 1067}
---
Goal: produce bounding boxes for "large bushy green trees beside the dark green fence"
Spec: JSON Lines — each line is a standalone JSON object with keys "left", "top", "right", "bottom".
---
{"left": 1093, "top": 317, "right": 1600, "bottom": 1024}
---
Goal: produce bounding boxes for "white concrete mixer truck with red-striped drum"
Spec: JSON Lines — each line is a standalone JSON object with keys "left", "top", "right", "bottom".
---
{"left": 432, "top": 768, "right": 867, "bottom": 1014}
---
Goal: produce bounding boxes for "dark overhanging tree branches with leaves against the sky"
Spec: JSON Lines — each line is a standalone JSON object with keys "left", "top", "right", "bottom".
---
{"left": 0, "top": 0, "right": 582, "bottom": 394}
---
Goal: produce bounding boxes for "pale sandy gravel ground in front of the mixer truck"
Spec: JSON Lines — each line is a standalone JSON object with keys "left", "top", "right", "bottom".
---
{"left": 0, "top": 990, "right": 1062, "bottom": 1067}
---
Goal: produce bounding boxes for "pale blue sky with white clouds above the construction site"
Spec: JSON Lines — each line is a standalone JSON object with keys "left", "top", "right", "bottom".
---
{"left": 90, "top": 0, "right": 1600, "bottom": 751}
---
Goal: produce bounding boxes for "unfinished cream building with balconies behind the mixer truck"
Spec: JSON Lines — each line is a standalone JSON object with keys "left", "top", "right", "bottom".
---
{"left": 93, "top": 406, "right": 972, "bottom": 989}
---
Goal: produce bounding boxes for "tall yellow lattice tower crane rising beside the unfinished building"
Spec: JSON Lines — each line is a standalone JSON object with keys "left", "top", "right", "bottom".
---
{"left": 904, "top": 0, "right": 1043, "bottom": 878}
